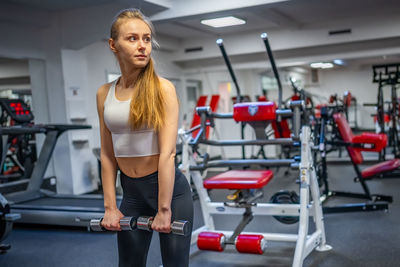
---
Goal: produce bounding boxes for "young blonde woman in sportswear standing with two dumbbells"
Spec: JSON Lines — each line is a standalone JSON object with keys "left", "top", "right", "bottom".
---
{"left": 97, "top": 9, "right": 193, "bottom": 267}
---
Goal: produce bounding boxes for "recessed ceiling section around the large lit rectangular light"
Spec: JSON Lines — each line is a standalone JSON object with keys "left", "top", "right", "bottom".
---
{"left": 151, "top": 0, "right": 400, "bottom": 39}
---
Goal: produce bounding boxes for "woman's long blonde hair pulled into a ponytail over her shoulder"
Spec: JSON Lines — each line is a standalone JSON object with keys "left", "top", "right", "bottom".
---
{"left": 110, "top": 8, "right": 165, "bottom": 131}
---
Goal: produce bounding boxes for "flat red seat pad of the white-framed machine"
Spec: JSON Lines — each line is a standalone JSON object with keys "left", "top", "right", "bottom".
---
{"left": 203, "top": 170, "right": 274, "bottom": 189}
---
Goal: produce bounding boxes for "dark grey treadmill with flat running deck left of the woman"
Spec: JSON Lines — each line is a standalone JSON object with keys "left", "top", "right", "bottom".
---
{"left": 0, "top": 100, "right": 121, "bottom": 227}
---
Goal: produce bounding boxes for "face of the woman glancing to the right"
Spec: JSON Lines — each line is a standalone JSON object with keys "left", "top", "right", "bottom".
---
{"left": 110, "top": 19, "right": 151, "bottom": 68}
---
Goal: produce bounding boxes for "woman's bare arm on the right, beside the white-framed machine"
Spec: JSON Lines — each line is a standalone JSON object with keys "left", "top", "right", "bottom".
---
{"left": 152, "top": 79, "right": 179, "bottom": 233}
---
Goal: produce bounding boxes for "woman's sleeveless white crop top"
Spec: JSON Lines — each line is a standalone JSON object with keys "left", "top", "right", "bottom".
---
{"left": 104, "top": 79, "right": 160, "bottom": 157}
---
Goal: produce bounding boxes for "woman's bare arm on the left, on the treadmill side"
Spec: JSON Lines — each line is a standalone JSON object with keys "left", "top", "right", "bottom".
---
{"left": 96, "top": 85, "right": 122, "bottom": 230}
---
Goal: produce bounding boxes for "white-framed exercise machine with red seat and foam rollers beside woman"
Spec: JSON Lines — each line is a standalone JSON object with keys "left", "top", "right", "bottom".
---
{"left": 180, "top": 102, "right": 331, "bottom": 267}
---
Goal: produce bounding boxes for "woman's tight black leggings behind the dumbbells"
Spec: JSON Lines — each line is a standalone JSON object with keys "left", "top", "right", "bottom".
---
{"left": 118, "top": 169, "right": 193, "bottom": 267}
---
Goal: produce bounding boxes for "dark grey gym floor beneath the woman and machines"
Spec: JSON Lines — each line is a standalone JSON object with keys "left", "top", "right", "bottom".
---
{"left": 0, "top": 163, "right": 400, "bottom": 267}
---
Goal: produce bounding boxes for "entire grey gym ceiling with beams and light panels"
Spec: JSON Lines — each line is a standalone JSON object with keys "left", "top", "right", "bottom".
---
{"left": 0, "top": 0, "right": 400, "bottom": 69}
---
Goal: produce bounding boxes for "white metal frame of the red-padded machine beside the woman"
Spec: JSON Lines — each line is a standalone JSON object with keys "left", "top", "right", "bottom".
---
{"left": 181, "top": 126, "right": 331, "bottom": 267}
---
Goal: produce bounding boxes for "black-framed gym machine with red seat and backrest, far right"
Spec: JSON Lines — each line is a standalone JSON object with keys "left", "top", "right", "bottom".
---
{"left": 314, "top": 105, "right": 392, "bottom": 214}
